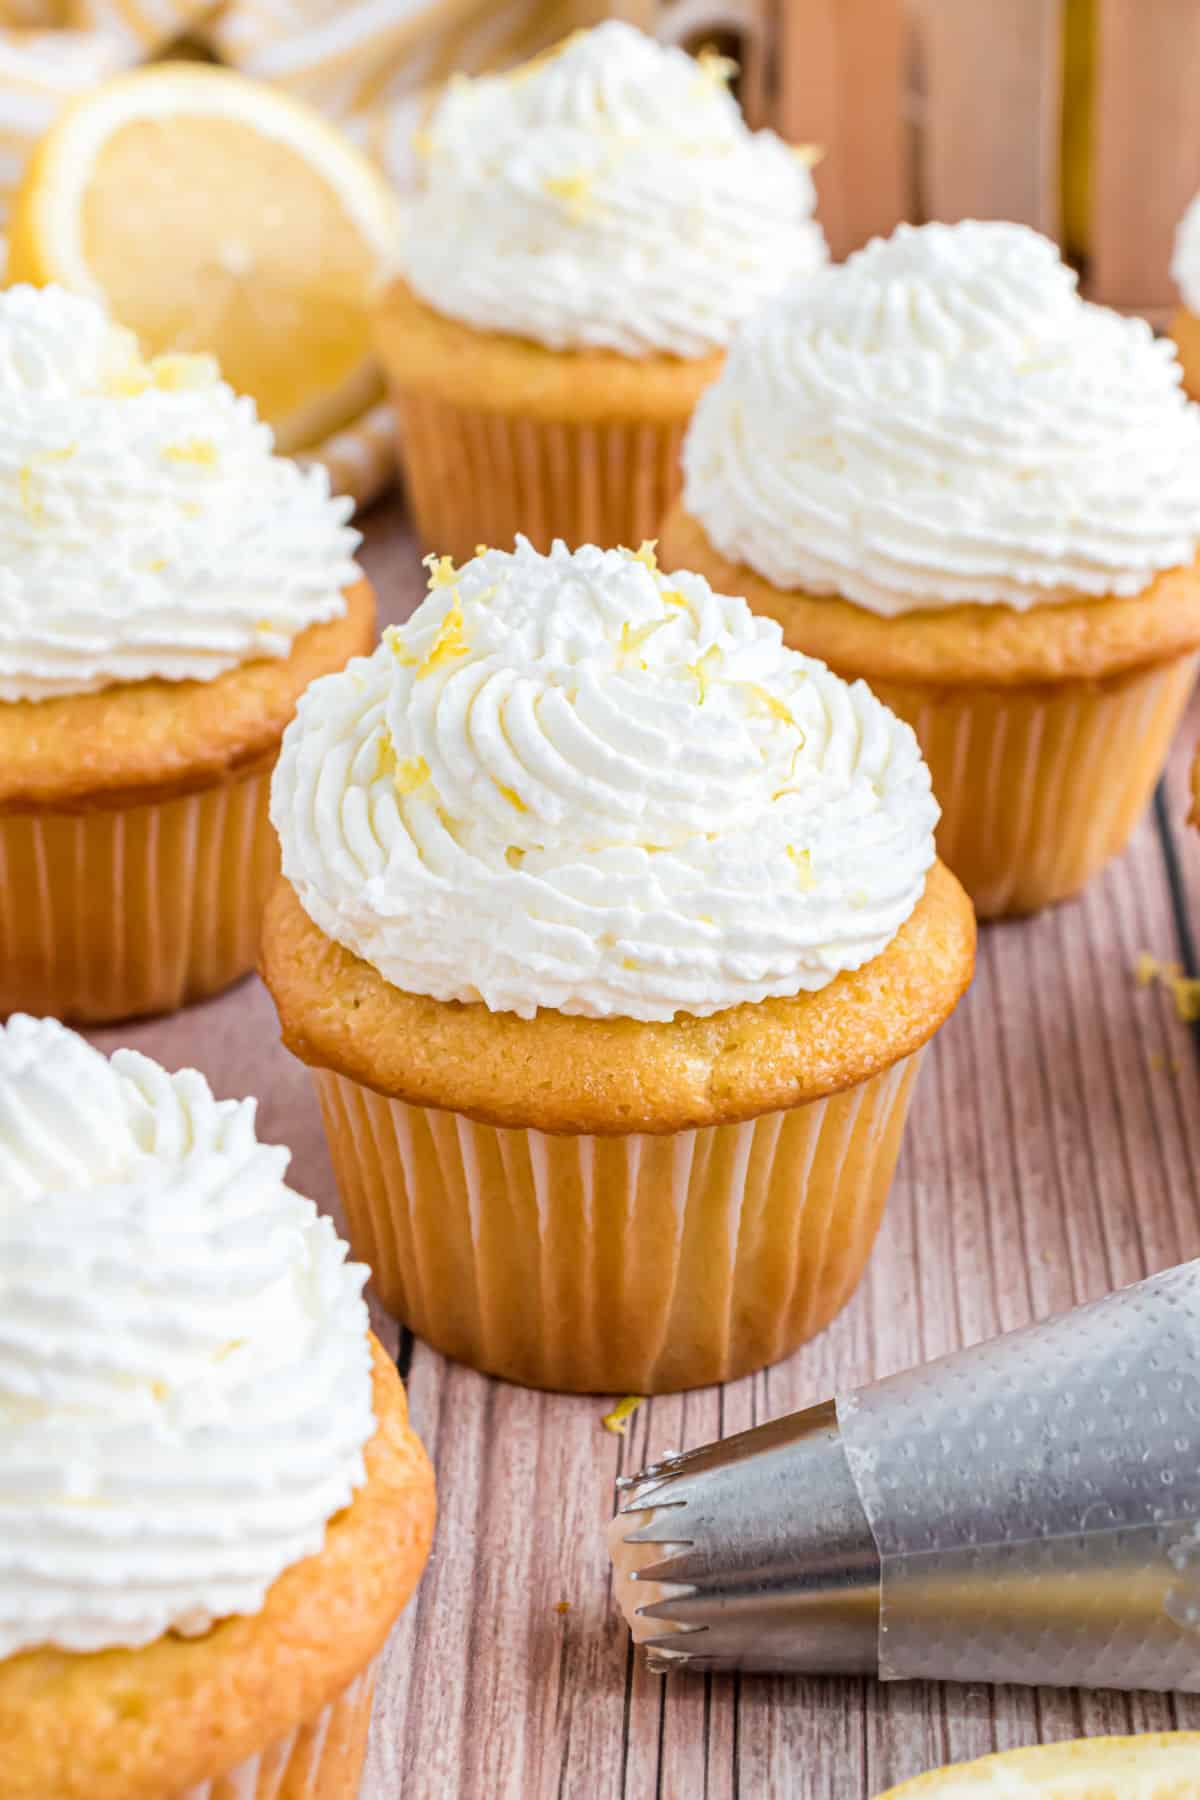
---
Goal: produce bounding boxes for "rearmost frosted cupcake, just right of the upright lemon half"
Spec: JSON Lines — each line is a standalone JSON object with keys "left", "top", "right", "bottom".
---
{"left": 378, "top": 22, "right": 826, "bottom": 558}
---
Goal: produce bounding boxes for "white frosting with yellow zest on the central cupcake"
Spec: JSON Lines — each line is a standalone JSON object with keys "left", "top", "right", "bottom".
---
{"left": 272, "top": 538, "right": 937, "bottom": 1019}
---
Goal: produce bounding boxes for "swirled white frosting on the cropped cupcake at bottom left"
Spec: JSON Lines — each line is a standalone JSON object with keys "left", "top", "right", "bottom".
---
{"left": 0, "top": 1013, "right": 374, "bottom": 1658}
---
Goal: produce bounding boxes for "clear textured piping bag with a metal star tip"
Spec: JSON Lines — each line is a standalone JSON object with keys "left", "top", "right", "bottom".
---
{"left": 610, "top": 1260, "right": 1200, "bottom": 1694}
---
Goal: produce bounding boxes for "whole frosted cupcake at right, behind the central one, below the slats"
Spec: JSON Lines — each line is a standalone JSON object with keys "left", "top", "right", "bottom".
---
{"left": 658, "top": 221, "right": 1200, "bottom": 916}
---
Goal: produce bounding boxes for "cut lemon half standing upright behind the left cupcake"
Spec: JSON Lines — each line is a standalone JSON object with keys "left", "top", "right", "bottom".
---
{"left": 9, "top": 63, "right": 398, "bottom": 450}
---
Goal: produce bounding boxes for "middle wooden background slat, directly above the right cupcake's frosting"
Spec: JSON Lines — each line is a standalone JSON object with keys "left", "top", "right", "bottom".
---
{"left": 914, "top": 0, "right": 1061, "bottom": 234}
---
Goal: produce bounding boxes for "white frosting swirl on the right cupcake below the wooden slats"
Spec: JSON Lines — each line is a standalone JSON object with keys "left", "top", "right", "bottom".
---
{"left": 684, "top": 221, "right": 1200, "bottom": 614}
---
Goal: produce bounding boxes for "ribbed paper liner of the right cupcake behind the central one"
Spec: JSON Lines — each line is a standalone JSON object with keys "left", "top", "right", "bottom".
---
{"left": 873, "top": 655, "right": 1198, "bottom": 918}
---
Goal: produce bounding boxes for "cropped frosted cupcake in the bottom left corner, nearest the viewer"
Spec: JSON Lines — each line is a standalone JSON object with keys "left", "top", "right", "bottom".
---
{"left": 0, "top": 1015, "right": 434, "bottom": 1800}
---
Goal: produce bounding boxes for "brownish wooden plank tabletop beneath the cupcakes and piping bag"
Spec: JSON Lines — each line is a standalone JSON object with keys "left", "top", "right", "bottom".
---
{"left": 89, "top": 502, "right": 1200, "bottom": 1800}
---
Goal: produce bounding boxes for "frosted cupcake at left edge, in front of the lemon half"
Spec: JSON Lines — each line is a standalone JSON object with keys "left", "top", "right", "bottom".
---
{"left": 0, "top": 286, "right": 374, "bottom": 1021}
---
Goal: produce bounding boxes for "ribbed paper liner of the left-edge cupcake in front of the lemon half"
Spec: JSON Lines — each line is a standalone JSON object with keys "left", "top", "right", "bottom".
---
{"left": 0, "top": 769, "right": 279, "bottom": 1024}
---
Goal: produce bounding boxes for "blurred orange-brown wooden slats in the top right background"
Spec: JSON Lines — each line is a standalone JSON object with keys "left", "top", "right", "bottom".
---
{"left": 744, "top": 0, "right": 1200, "bottom": 319}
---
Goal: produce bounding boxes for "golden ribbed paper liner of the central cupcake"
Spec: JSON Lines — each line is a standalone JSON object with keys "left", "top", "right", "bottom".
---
{"left": 313, "top": 1055, "right": 919, "bottom": 1393}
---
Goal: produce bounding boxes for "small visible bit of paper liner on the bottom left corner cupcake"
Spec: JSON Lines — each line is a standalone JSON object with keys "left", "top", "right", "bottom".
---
{"left": 176, "top": 1663, "right": 376, "bottom": 1800}
